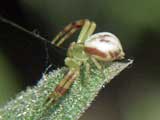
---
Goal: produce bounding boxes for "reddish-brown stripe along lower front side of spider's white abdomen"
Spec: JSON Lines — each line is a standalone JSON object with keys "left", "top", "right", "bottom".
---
{"left": 84, "top": 47, "right": 106, "bottom": 58}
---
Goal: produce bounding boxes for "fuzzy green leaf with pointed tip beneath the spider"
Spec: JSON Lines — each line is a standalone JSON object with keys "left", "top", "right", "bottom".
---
{"left": 0, "top": 60, "right": 133, "bottom": 120}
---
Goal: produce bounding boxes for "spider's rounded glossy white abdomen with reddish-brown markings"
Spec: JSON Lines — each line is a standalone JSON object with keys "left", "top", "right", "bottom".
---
{"left": 84, "top": 32, "right": 124, "bottom": 62}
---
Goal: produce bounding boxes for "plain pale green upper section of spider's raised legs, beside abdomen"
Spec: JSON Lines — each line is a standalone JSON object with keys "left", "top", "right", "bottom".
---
{"left": 78, "top": 22, "right": 96, "bottom": 43}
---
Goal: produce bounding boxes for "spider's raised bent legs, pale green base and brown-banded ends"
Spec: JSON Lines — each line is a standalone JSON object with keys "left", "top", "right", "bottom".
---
{"left": 51, "top": 19, "right": 96, "bottom": 47}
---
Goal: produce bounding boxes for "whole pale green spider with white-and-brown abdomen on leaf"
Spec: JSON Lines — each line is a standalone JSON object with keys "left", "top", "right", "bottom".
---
{"left": 46, "top": 19, "right": 125, "bottom": 105}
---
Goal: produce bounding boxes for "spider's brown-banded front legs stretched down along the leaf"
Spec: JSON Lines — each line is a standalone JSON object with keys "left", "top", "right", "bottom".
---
{"left": 46, "top": 57, "right": 81, "bottom": 106}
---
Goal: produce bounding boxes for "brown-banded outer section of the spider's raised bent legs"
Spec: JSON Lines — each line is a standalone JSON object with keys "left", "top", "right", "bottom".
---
{"left": 51, "top": 19, "right": 90, "bottom": 46}
